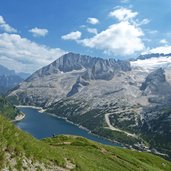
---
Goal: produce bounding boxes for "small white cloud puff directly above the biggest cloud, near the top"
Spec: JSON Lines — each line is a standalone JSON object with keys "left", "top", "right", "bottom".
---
{"left": 109, "top": 7, "right": 138, "bottom": 21}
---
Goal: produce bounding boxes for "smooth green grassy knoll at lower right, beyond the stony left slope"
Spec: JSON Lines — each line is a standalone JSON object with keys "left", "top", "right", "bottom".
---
{"left": 43, "top": 136, "right": 171, "bottom": 171}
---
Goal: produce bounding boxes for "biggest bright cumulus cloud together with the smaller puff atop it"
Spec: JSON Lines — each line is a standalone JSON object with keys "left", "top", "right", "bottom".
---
{"left": 62, "top": 7, "right": 150, "bottom": 56}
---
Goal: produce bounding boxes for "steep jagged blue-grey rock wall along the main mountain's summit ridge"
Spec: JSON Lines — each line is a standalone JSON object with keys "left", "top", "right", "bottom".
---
{"left": 32, "top": 52, "right": 131, "bottom": 79}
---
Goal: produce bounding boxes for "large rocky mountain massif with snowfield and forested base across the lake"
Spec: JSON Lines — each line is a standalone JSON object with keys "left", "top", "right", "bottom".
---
{"left": 8, "top": 53, "right": 171, "bottom": 159}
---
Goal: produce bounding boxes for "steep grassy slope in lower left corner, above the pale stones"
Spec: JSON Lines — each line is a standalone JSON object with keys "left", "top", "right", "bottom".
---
{"left": 0, "top": 116, "right": 65, "bottom": 169}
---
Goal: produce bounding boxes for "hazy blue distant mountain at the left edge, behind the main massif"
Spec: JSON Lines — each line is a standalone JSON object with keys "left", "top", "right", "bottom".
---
{"left": 0, "top": 65, "right": 23, "bottom": 94}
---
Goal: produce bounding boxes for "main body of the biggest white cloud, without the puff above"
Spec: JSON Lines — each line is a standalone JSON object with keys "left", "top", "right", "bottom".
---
{"left": 77, "top": 21, "right": 144, "bottom": 55}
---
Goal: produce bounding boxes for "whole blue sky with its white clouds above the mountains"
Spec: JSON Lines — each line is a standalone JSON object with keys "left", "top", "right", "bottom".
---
{"left": 0, "top": 0, "right": 171, "bottom": 72}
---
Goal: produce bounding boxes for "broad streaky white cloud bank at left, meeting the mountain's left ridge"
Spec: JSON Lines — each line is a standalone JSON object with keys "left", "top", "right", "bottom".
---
{"left": 0, "top": 33, "right": 66, "bottom": 72}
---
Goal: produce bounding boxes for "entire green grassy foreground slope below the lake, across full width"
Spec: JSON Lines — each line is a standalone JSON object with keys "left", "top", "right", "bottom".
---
{"left": 0, "top": 116, "right": 171, "bottom": 171}
